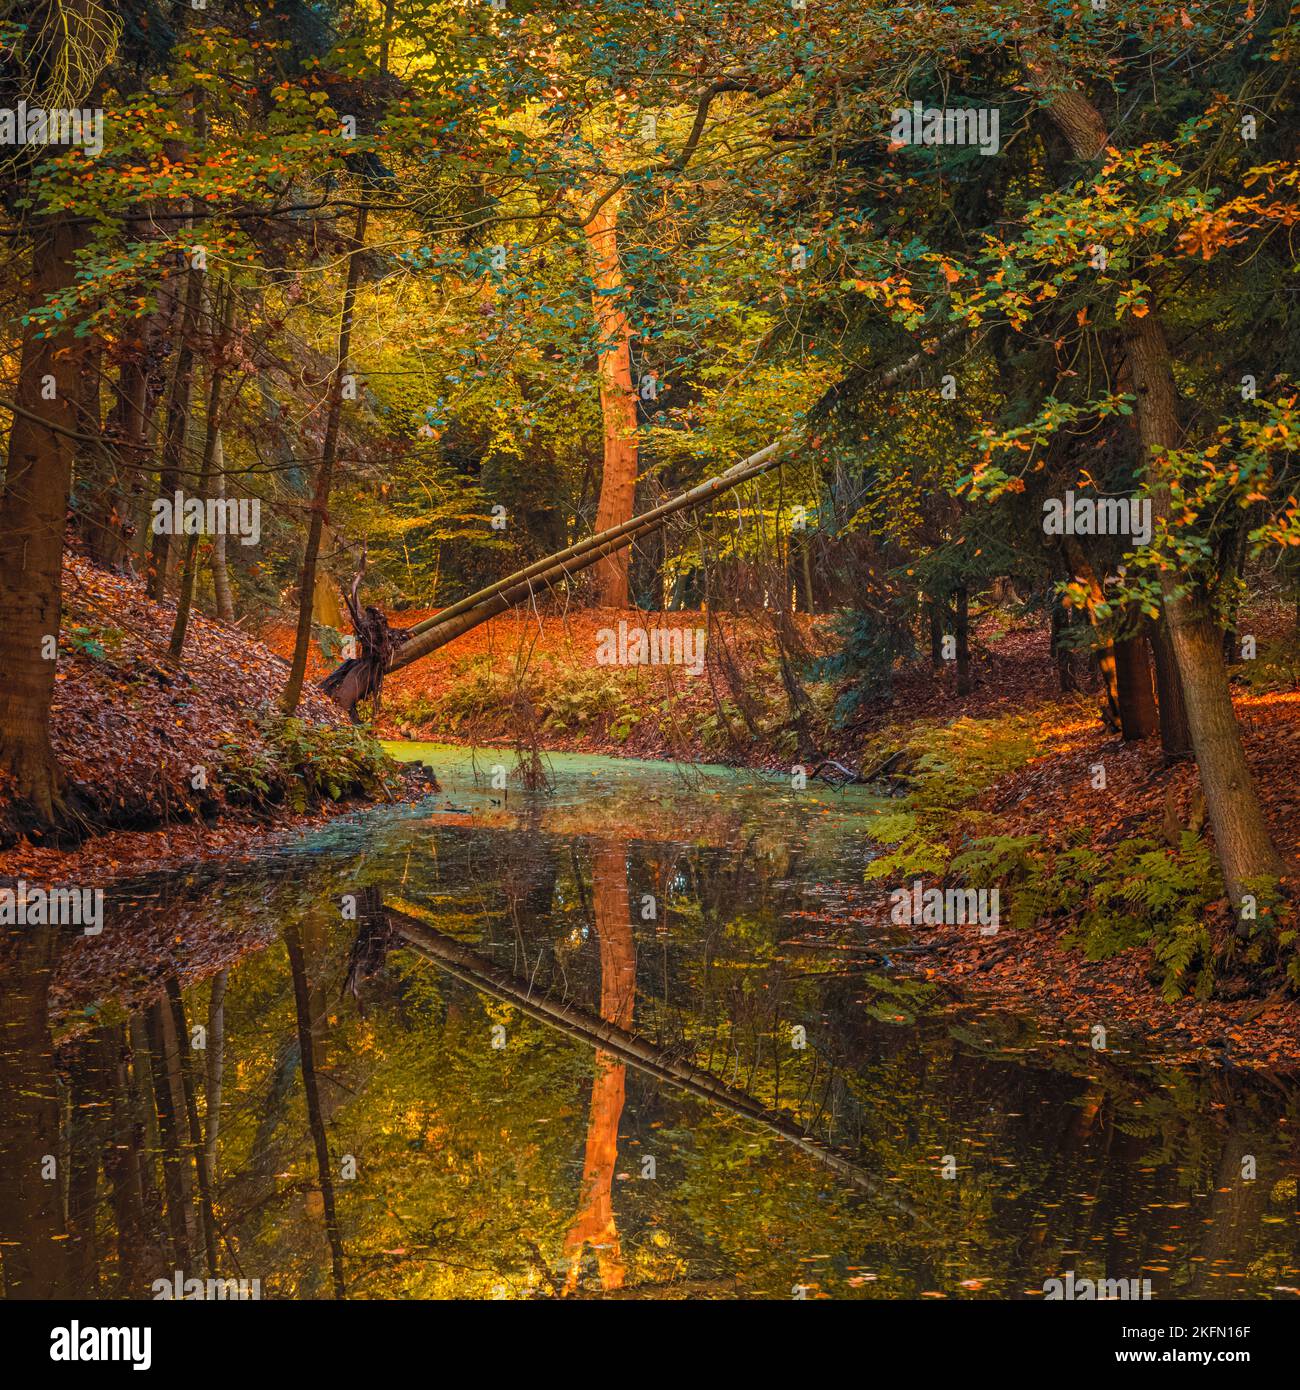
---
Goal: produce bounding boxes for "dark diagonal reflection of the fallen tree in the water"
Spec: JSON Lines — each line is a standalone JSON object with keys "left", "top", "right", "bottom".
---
{"left": 385, "top": 908, "right": 916, "bottom": 1218}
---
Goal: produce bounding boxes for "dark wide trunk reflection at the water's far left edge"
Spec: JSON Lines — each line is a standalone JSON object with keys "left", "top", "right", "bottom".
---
{"left": 0, "top": 927, "right": 76, "bottom": 1298}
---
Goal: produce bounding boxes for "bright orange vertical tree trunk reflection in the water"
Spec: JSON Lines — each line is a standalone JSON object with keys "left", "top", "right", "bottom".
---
{"left": 564, "top": 840, "right": 637, "bottom": 1291}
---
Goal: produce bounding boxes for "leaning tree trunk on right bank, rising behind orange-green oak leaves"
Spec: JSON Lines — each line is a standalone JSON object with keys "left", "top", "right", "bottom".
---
{"left": 1026, "top": 56, "right": 1282, "bottom": 931}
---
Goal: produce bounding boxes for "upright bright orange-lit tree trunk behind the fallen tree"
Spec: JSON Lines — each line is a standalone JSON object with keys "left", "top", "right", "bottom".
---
{"left": 585, "top": 193, "right": 637, "bottom": 609}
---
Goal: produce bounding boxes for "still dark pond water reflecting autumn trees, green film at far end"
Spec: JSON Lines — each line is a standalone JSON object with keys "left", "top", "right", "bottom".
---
{"left": 0, "top": 745, "right": 1300, "bottom": 1300}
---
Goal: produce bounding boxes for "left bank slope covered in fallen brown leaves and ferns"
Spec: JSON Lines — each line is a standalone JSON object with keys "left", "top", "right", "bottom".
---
{"left": 0, "top": 556, "right": 417, "bottom": 856}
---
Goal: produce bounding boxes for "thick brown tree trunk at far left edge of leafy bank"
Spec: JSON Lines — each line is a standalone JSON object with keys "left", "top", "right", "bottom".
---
{"left": 0, "top": 221, "right": 81, "bottom": 826}
